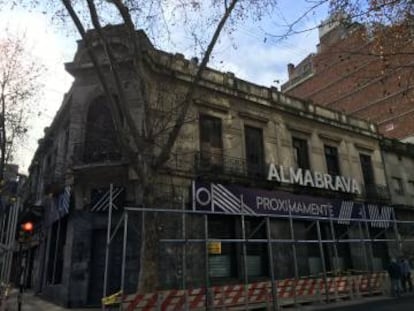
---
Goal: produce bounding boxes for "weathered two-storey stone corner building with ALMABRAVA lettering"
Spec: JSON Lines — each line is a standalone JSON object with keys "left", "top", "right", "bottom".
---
{"left": 25, "top": 27, "right": 408, "bottom": 306}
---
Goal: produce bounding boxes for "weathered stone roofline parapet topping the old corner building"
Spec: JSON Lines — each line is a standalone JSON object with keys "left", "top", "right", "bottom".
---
{"left": 66, "top": 28, "right": 378, "bottom": 138}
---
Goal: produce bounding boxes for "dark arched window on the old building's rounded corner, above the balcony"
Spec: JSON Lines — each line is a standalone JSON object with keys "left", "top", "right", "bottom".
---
{"left": 84, "top": 97, "right": 121, "bottom": 163}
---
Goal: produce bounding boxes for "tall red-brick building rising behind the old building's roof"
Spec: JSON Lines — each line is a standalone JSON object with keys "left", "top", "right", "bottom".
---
{"left": 282, "top": 18, "right": 414, "bottom": 141}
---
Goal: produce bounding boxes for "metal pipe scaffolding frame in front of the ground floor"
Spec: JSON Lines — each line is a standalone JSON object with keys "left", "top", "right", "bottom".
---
{"left": 102, "top": 185, "right": 414, "bottom": 310}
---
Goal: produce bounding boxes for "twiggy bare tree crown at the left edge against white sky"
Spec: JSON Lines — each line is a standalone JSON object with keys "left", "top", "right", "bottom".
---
{"left": 0, "top": 34, "right": 45, "bottom": 180}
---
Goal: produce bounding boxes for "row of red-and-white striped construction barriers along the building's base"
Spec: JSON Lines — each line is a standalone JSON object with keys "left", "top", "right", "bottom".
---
{"left": 102, "top": 272, "right": 386, "bottom": 311}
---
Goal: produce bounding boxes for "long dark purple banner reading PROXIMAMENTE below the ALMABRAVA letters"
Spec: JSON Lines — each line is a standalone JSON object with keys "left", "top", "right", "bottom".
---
{"left": 193, "top": 181, "right": 393, "bottom": 228}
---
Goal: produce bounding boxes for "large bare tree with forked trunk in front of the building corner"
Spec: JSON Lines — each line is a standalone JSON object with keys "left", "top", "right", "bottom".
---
{"left": 5, "top": 0, "right": 276, "bottom": 291}
